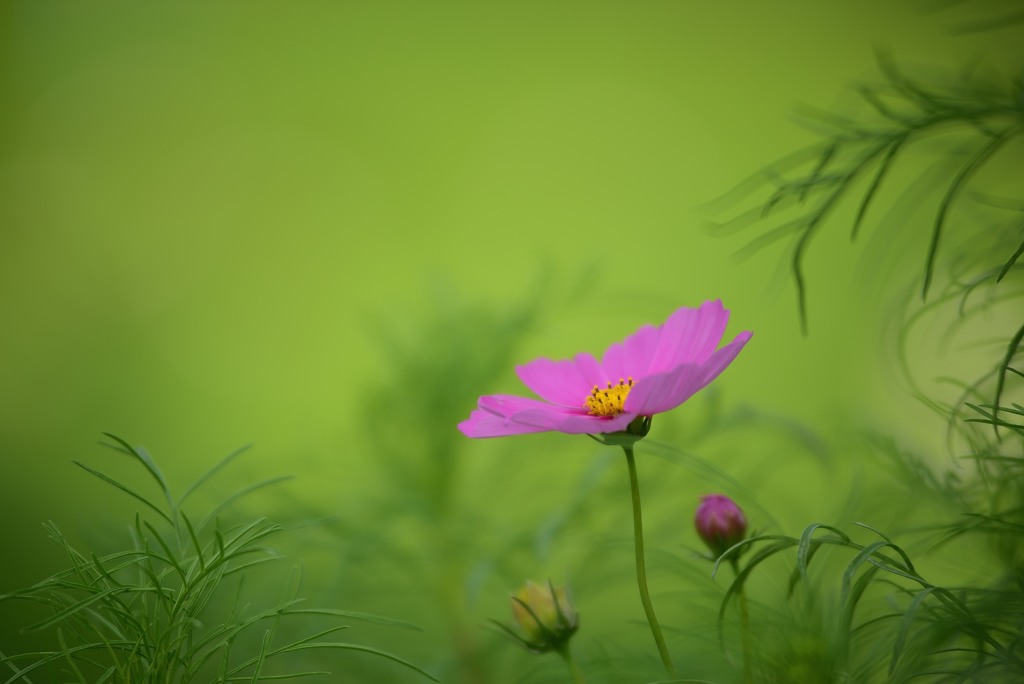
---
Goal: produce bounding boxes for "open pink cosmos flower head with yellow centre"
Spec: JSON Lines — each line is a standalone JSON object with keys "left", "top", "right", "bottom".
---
{"left": 459, "top": 301, "right": 752, "bottom": 437}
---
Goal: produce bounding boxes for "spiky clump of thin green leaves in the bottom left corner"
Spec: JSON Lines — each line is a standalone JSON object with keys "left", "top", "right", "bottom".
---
{"left": 0, "top": 434, "right": 436, "bottom": 684}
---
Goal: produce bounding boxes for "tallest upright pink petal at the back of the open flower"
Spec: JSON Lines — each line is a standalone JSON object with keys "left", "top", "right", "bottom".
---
{"left": 647, "top": 300, "right": 729, "bottom": 373}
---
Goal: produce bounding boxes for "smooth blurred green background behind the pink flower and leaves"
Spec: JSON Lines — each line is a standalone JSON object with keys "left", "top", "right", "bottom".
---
{"left": 0, "top": 0, "right": 1020, "bottom": 682}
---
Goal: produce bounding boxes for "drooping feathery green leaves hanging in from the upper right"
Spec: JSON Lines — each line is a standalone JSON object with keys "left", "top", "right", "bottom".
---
{"left": 720, "top": 54, "right": 1024, "bottom": 333}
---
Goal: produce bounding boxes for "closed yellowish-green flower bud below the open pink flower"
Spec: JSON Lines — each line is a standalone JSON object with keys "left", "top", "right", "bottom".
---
{"left": 512, "top": 582, "right": 580, "bottom": 653}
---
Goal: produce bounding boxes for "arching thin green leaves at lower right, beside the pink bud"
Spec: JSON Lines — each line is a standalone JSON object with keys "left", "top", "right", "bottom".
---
{"left": 715, "top": 523, "right": 1024, "bottom": 682}
